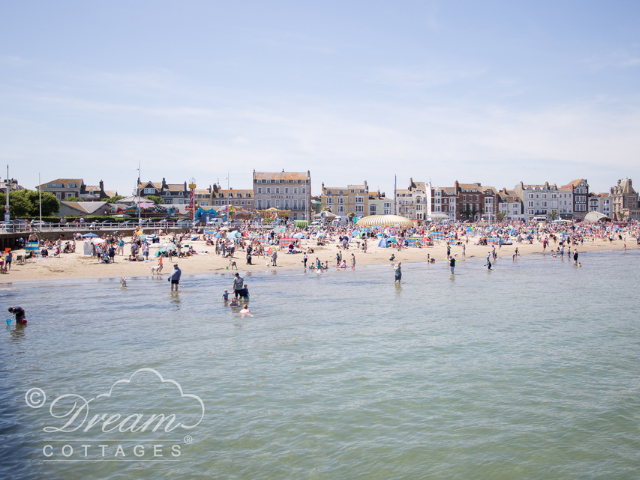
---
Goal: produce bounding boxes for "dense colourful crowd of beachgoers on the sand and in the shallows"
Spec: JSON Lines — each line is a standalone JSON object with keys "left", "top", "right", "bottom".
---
{"left": 6, "top": 218, "right": 640, "bottom": 324}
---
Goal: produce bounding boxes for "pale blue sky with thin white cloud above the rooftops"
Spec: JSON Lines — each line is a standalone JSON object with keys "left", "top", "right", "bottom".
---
{"left": 0, "top": 0, "right": 640, "bottom": 194}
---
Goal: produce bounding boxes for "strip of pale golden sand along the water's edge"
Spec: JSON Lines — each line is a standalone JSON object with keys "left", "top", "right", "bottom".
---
{"left": 0, "top": 237, "right": 638, "bottom": 283}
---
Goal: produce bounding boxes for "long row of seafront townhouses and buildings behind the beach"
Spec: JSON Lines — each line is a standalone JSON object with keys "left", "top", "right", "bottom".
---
{"left": 33, "top": 174, "right": 640, "bottom": 221}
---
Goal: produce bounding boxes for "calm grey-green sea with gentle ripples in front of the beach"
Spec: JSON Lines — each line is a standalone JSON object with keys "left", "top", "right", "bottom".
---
{"left": 0, "top": 252, "right": 640, "bottom": 480}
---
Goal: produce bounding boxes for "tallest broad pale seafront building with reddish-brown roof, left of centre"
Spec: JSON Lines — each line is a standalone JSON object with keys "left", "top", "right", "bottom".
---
{"left": 253, "top": 170, "right": 311, "bottom": 220}
